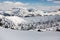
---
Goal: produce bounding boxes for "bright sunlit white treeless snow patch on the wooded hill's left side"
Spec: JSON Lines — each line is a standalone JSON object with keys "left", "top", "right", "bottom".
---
{"left": 6, "top": 16, "right": 27, "bottom": 24}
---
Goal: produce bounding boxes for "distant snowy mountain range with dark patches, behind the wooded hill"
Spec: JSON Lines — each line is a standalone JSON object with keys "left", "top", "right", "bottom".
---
{"left": 0, "top": 7, "right": 60, "bottom": 17}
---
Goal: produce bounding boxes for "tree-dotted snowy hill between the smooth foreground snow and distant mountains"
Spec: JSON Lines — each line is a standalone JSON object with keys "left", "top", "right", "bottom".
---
{"left": 0, "top": 15, "right": 60, "bottom": 31}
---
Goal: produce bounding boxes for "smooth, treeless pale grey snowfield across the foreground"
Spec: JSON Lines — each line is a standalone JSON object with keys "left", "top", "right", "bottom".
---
{"left": 0, "top": 27, "right": 60, "bottom": 40}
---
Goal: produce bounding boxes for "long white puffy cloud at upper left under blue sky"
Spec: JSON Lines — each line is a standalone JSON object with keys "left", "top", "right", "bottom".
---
{"left": 0, "top": 1, "right": 29, "bottom": 10}
